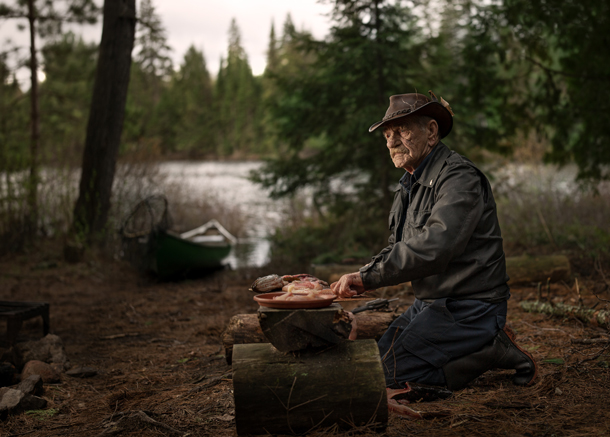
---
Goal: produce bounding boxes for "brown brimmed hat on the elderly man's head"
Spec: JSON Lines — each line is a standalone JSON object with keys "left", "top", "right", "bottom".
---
{"left": 369, "top": 91, "right": 453, "bottom": 138}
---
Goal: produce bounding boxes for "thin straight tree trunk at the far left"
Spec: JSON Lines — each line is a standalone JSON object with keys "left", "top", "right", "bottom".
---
{"left": 26, "top": 0, "right": 40, "bottom": 236}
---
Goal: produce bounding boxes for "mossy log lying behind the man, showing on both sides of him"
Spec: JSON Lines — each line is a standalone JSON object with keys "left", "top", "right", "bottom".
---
{"left": 312, "top": 255, "right": 571, "bottom": 284}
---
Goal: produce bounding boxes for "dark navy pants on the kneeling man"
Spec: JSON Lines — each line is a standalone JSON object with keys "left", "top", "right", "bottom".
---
{"left": 378, "top": 299, "right": 506, "bottom": 388}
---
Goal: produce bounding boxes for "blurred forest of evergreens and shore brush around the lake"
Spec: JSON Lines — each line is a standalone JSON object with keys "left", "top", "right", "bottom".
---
{"left": 0, "top": 0, "right": 610, "bottom": 265}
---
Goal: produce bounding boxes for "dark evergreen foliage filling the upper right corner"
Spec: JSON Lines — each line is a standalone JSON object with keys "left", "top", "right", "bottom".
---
{"left": 471, "top": 0, "right": 610, "bottom": 179}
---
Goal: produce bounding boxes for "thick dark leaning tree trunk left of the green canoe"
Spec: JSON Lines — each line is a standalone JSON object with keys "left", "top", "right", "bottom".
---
{"left": 68, "top": 0, "right": 136, "bottom": 244}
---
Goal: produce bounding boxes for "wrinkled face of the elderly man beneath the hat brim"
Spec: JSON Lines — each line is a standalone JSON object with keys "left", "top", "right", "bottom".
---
{"left": 383, "top": 118, "right": 436, "bottom": 173}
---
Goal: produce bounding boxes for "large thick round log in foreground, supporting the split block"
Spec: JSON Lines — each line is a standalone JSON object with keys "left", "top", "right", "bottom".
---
{"left": 233, "top": 340, "right": 388, "bottom": 435}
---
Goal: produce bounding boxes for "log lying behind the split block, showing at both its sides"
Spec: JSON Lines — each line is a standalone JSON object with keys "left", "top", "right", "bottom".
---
{"left": 222, "top": 311, "right": 398, "bottom": 365}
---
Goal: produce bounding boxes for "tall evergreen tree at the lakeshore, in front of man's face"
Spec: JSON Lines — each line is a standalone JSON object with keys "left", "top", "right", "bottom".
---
{"left": 249, "top": 0, "right": 424, "bottom": 254}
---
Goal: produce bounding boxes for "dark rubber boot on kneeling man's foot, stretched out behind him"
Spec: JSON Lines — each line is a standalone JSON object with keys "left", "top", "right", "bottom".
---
{"left": 443, "top": 325, "right": 538, "bottom": 390}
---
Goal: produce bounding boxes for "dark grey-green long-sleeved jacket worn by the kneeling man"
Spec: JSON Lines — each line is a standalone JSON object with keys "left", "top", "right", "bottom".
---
{"left": 360, "top": 143, "right": 509, "bottom": 302}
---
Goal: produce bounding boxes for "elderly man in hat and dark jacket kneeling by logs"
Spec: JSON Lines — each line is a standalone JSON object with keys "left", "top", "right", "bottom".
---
{"left": 331, "top": 91, "right": 537, "bottom": 390}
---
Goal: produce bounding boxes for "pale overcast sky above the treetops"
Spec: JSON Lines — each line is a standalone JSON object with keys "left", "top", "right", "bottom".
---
{"left": 0, "top": 0, "right": 330, "bottom": 82}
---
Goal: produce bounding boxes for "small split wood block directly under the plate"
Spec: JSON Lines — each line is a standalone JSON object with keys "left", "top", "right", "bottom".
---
{"left": 258, "top": 303, "right": 352, "bottom": 352}
